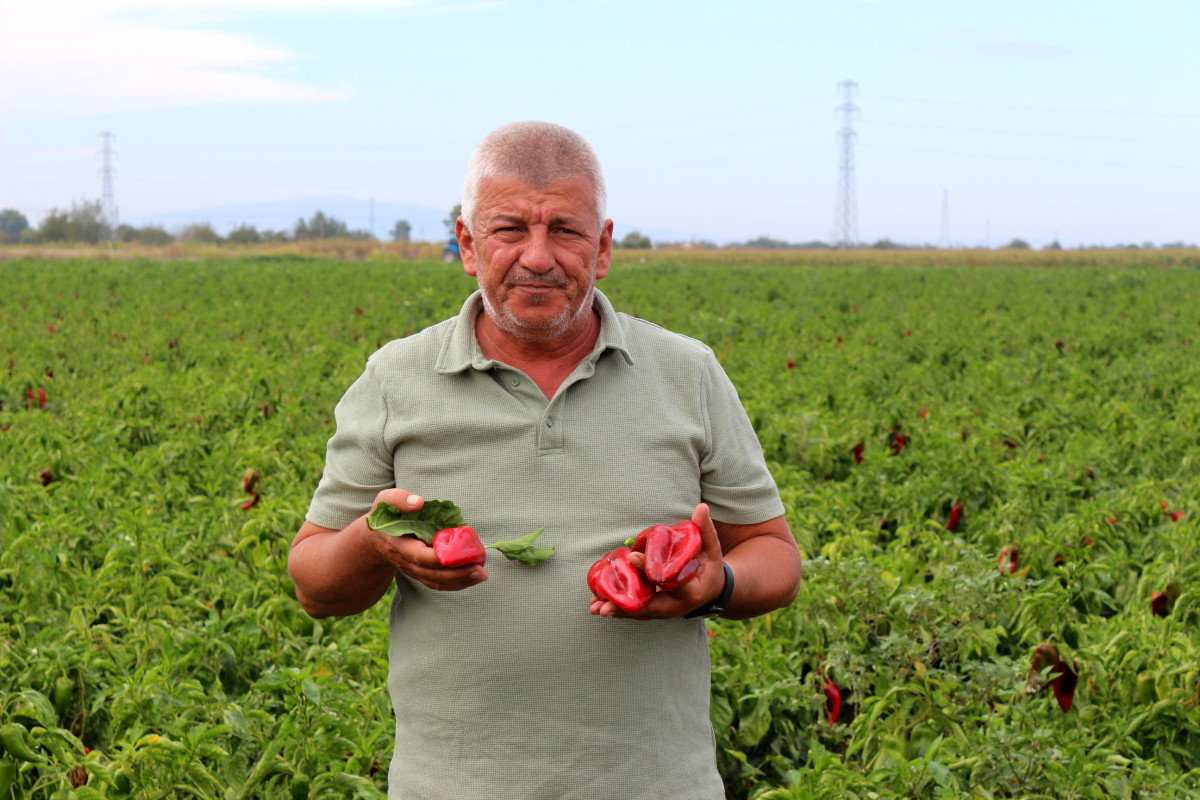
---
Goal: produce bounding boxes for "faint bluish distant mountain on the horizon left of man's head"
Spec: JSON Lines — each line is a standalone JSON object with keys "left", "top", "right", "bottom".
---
{"left": 121, "top": 197, "right": 450, "bottom": 241}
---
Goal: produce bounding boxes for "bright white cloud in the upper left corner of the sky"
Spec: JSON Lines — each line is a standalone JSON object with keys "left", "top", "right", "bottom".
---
{"left": 0, "top": 0, "right": 416, "bottom": 122}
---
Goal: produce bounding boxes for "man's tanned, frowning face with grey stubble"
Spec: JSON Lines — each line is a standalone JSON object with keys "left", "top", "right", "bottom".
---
{"left": 456, "top": 175, "right": 612, "bottom": 344}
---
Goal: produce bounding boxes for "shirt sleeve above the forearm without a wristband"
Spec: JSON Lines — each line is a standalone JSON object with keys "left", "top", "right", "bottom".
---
{"left": 306, "top": 362, "right": 396, "bottom": 530}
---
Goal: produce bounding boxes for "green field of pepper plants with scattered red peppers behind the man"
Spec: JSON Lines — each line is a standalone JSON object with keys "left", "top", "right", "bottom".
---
{"left": 0, "top": 251, "right": 1200, "bottom": 800}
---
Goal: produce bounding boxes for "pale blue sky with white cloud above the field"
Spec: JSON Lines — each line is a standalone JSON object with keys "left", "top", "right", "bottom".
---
{"left": 0, "top": 0, "right": 1200, "bottom": 247}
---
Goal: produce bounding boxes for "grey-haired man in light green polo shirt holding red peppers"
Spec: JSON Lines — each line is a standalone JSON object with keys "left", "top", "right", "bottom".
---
{"left": 289, "top": 122, "right": 800, "bottom": 800}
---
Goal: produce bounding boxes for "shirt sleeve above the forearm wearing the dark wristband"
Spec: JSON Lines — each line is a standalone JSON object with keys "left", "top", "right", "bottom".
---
{"left": 700, "top": 351, "right": 784, "bottom": 525}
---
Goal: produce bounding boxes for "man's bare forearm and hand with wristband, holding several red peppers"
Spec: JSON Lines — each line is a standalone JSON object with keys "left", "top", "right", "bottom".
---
{"left": 590, "top": 503, "right": 802, "bottom": 619}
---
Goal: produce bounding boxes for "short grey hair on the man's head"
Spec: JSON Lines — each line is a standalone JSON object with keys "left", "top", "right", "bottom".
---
{"left": 462, "top": 121, "right": 608, "bottom": 228}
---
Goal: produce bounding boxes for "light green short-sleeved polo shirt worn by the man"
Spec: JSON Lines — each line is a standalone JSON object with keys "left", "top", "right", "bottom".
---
{"left": 307, "top": 291, "right": 784, "bottom": 800}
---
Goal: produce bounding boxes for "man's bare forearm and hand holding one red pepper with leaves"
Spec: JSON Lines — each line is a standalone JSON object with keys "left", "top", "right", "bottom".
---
{"left": 288, "top": 489, "right": 487, "bottom": 619}
